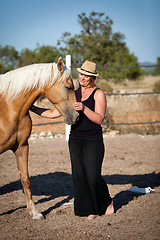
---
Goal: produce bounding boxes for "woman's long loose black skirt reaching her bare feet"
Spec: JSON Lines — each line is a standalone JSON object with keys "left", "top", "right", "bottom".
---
{"left": 69, "top": 138, "right": 112, "bottom": 216}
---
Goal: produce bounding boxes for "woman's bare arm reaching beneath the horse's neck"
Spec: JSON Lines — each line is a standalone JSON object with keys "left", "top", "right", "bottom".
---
{"left": 30, "top": 105, "right": 61, "bottom": 119}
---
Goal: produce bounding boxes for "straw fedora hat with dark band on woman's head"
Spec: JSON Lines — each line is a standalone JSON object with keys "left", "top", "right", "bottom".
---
{"left": 77, "top": 60, "right": 98, "bottom": 77}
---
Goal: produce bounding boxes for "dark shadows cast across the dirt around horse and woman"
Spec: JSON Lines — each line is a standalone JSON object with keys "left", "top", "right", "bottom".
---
{"left": 0, "top": 172, "right": 160, "bottom": 215}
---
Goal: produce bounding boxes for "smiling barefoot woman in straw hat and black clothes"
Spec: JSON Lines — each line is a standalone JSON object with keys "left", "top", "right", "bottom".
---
{"left": 32, "top": 60, "right": 114, "bottom": 219}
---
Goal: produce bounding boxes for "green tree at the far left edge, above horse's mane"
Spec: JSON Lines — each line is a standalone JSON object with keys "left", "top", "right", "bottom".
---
{"left": 0, "top": 45, "right": 19, "bottom": 74}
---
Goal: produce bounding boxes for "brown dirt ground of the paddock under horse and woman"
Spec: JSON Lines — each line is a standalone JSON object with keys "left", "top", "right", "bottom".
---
{"left": 0, "top": 134, "right": 160, "bottom": 240}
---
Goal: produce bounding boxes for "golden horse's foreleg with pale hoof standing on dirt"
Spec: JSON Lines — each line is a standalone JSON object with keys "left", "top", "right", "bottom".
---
{"left": 15, "top": 143, "right": 43, "bottom": 219}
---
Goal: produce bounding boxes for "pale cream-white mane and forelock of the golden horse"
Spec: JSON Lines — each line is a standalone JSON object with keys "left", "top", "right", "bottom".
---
{"left": 0, "top": 63, "right": 70, "bottom": 100}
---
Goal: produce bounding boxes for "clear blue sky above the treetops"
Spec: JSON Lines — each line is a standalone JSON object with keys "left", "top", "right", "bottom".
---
{"left": 0, "top": 0, "right": 160, "bottom": 63}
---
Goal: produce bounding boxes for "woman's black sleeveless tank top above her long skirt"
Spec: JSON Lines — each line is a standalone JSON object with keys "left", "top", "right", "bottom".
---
{"left": 70, "top": 88, "right": 102, "bottom": 140}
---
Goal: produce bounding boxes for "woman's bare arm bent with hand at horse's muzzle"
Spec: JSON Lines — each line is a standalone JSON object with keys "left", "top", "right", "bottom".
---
{"left": 74, "top": 89, "right": 107, "bottom": 124}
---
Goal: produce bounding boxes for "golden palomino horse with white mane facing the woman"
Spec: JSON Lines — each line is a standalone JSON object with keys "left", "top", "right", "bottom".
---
{"left": 0, "top": 57, "right": 78, "bottom": 219}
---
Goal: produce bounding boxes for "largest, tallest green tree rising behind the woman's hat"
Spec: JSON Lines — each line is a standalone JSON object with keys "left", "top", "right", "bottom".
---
{"left": 58, "top": 12, "right": 142, "bottom": 82}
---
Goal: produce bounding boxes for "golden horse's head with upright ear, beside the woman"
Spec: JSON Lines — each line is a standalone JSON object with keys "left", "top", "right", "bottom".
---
{"left": 45, "top": 57, "right": 79, "bottom": 125}
